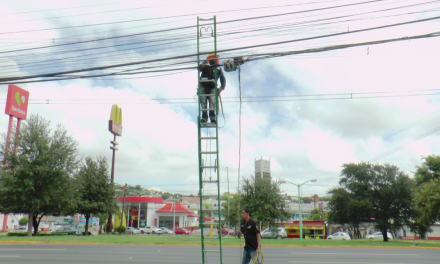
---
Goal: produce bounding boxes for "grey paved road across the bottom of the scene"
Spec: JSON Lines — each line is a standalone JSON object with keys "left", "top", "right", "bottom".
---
{"left": 0, "top": 244, "right": 440, "bottom": 264}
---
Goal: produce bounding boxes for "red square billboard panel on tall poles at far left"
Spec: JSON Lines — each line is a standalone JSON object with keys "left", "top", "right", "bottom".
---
{"left": 5, "top": 84, "right": 29, "bottom": 120}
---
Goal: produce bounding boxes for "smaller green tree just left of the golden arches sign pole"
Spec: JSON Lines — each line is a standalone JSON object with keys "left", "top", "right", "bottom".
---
{"left": 75, "top": 157, "right": 117, "bottom": 235}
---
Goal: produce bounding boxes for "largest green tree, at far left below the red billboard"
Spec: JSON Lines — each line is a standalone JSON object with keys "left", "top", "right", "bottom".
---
{"left": 0, "top": 115, "right": 78, "bottom": 236}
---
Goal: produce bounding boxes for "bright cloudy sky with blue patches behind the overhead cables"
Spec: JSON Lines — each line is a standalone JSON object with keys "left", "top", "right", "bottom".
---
{"left": 0, "top": 0, "right": 440, "bottom": 195}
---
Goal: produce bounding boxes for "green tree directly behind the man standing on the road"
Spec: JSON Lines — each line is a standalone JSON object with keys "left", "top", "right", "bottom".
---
{"left": 240, "top": 177, "right": 291, "bottom": 226}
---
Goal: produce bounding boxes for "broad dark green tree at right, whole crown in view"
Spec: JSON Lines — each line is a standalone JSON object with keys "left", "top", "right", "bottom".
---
{"left": 329, "top": 163, "right": 415, "bottom": 242}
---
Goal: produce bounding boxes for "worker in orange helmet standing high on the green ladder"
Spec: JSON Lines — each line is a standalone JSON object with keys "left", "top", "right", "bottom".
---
{"left": 200, "top": 53, "right": 226, "bottom": 124}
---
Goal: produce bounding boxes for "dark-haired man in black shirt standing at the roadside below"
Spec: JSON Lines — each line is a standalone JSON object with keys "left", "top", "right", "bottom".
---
{"left": 238, "top": 208, "right": 261, "bottom": 264}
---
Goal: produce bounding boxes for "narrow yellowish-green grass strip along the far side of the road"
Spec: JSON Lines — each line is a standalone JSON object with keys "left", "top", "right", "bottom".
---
{"left": 0, "top": 235, "right": 440, "bottom": 250}
